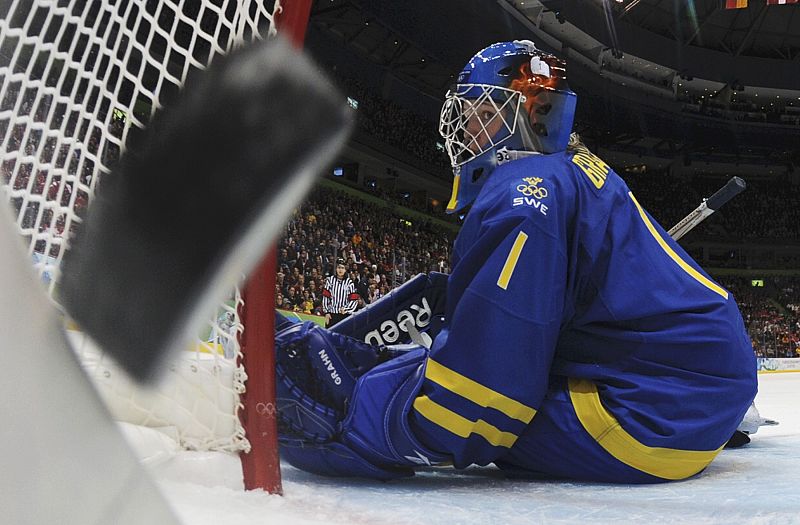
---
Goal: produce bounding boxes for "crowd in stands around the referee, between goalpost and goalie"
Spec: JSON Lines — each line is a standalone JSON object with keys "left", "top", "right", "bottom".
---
{"left": 275, "top": 187, "right": 453, "bottom": 315}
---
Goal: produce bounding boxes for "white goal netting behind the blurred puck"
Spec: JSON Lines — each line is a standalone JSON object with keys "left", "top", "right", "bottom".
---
{"left": 0, "top": 0, "right": 280, "bottom": 450}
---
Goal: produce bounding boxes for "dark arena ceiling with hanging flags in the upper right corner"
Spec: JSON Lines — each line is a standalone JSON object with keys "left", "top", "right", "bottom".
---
{"left": 524, "top": 0, "right": 800, "bottom": 90}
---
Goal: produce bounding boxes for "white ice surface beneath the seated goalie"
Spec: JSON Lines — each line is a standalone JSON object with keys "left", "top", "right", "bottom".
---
{"left": 148, "top": 373, "right": 800, "bottom": 525}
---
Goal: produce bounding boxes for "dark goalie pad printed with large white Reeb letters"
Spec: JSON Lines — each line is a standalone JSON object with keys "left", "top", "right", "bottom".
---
{"left": 332, "top": 272, "right": 447, "bottom": 345}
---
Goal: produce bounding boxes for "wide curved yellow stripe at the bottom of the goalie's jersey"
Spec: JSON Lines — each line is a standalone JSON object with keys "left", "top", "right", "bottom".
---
{"left": 569, "top": 379, "right": 724, "bottom": 480}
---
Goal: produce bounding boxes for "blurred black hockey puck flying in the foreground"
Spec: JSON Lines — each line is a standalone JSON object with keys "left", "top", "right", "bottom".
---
{"left": 60, "top": 39, "right": 352, "bottom": 381}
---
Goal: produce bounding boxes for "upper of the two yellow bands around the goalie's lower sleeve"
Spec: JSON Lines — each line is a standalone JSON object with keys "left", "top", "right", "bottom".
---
{"left": 425, "top": 358, "right": 536, "bottom": 424}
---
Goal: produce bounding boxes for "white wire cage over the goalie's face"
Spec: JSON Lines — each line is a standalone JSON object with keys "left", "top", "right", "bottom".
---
{"left": 439, "top": 84, "right": 525, "bottom": 168}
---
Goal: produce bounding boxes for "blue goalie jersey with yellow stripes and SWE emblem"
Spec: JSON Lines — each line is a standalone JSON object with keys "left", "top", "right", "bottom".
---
{"left": 410, "top": 146, "right": 757, "bottom": 482}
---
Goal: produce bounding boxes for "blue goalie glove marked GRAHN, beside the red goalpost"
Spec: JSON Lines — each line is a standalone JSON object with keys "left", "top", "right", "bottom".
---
{"left": 275, "top": 323, "right": 448, "bottom": 479}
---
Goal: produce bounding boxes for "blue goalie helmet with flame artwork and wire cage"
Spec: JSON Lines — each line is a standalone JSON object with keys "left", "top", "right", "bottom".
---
{"left": 439, "top": 40, "right": 576, "bottom": 213}
